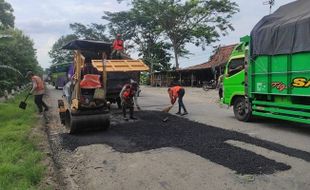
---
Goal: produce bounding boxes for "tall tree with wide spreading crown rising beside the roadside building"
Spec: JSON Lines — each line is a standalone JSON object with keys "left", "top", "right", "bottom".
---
{"left": 112, "top": 0, "right": 239, "bottom": 68}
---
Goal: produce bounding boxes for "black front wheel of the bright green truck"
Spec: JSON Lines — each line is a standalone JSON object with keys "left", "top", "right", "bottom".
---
{"left": 234, "top": 97, "right": 252, "bottom": 121}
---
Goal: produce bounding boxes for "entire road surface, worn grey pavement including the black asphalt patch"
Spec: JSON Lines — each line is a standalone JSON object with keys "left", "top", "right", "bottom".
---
{"left": 44, "top": 87, "right": 310, "bottom": 190}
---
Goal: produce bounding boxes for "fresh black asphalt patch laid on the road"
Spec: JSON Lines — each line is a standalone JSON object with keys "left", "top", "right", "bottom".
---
{"left": 61, "top": 111, "right": 310, "bottom": 175}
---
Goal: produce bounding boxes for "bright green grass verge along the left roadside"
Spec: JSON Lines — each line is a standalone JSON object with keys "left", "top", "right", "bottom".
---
{"left": 0, "top": 91, "right": 45, "bottom": 190}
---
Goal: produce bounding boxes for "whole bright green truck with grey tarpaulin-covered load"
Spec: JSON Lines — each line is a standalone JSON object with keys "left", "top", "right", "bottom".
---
{"left": 222, "top": 0, "right": 310, "bottom": 124}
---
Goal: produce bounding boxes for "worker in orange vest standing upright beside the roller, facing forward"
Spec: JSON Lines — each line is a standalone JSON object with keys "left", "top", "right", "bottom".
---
{"left": 120, "top": 81, "right": 138, "bottom": 121}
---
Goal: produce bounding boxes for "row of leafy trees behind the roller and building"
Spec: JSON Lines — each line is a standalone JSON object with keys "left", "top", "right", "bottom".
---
{"left": 49, "top": 0, "right": 239, "bottom": 71}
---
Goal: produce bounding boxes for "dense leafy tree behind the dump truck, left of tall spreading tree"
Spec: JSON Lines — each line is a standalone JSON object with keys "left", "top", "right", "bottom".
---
{"left": 102, "top": 4, "right": 171, "bottom": 72}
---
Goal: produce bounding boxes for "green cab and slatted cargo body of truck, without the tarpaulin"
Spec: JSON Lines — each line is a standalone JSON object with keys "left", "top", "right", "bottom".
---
{"left": 222, "top": 36, "right": 310, "bottom": 124}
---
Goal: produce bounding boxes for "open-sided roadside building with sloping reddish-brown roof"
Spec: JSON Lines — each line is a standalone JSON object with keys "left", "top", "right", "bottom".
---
{"left": 151, "top": 44, "right": 237, "bottom": 87}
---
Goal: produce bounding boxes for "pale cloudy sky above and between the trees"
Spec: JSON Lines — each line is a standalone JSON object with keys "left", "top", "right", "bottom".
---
{"left": 6, "top": 0, "right": 294, "bottom": 68}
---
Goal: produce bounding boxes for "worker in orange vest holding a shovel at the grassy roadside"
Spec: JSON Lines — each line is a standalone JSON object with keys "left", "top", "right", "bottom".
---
{"left": 26, "top": 71, "right": 48, "bottom": 114}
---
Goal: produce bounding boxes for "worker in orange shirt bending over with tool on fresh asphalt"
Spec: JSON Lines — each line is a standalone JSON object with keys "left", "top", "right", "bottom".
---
{"left": 168, "top": 85, "right": 188, "bottom": 115}
